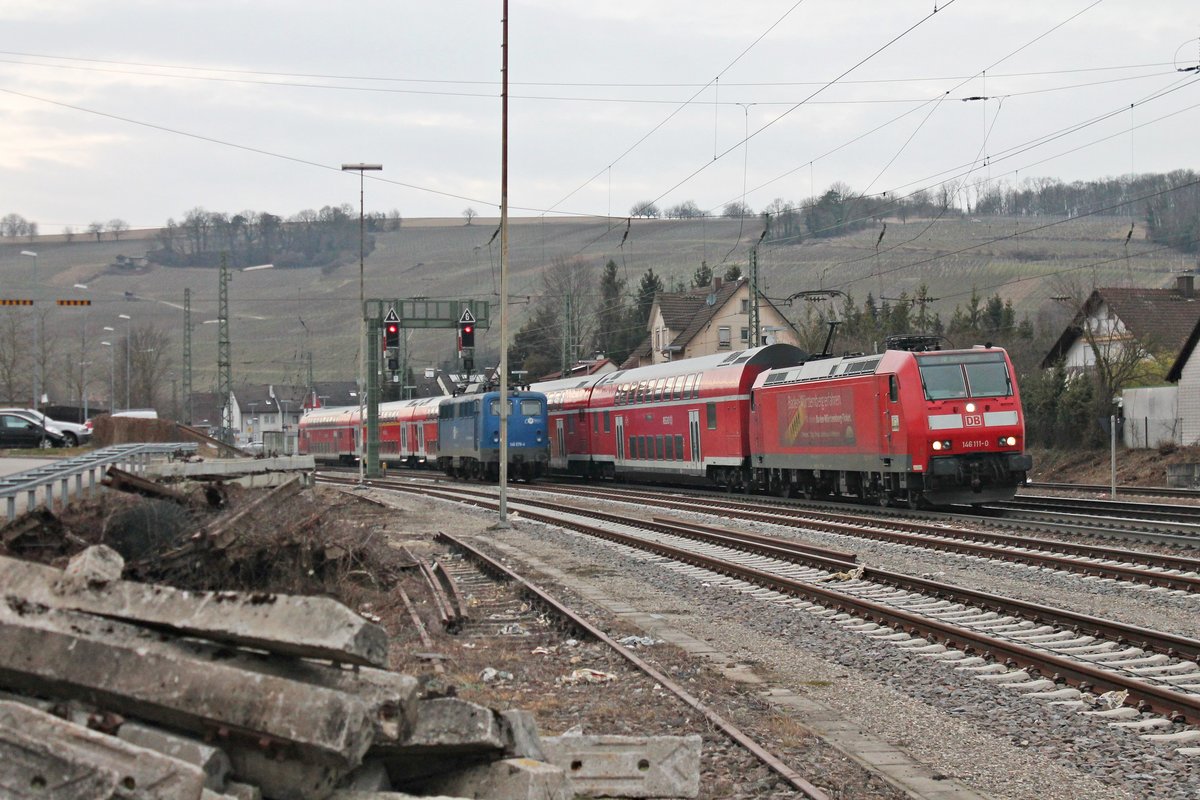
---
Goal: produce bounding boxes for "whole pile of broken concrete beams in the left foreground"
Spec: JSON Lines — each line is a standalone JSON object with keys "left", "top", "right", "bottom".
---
{"left": 0, "top": 546, "right": 700, "bottom": 800}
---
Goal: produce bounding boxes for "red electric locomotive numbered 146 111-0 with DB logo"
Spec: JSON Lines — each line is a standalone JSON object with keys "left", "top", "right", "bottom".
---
{"left": 750, "top": 347, "right": 1032, "bottom": 507}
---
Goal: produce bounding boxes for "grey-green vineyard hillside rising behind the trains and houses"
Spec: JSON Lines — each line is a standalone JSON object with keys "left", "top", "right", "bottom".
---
{"left": 0, "top": 217, "right": 1188, "bottom": 397}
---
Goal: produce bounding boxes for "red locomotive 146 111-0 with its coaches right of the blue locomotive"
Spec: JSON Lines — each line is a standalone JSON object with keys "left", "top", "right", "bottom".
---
{"left": 530, "top": 344, "right": 1032, "bottom": 507}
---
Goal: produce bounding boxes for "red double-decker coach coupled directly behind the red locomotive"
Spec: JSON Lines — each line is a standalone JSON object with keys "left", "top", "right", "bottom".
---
{"left": 588, "top": 344, "right": 804, "bottom": 488}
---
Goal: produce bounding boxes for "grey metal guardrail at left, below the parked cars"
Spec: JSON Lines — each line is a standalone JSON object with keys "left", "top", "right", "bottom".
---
{"left": 0, "top": 441, "right": 197, "bottom": 522}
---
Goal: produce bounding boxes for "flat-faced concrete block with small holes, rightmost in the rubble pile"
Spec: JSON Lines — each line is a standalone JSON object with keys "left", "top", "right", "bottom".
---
{"left": 541, "top": 734, "right": 701, "bottom": 798}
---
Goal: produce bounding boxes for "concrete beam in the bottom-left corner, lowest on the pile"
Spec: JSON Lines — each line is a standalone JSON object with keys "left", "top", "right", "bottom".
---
{"left": 0, "top": 702, "right": 204, "bottom": 800}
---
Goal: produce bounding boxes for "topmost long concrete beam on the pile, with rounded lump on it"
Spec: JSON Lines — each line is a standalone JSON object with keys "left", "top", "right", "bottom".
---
{"left": 0, "top": 548, "right": 388, "bottom": 667}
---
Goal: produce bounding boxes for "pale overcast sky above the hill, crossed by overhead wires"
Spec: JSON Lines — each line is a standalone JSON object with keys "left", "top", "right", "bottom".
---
{"left": 0, "top": 0, "right": 1200, "bottom": 233}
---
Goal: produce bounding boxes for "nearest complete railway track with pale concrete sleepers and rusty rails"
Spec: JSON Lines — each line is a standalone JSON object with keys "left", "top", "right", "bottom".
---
{"left": 316, "top": 472, "right": 1200, "bottom": 754}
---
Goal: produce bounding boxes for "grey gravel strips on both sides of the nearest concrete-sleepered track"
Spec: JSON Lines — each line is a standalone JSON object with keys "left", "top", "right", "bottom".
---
{"left": 384, "top": 482, "right": 1200, "bottom": 799}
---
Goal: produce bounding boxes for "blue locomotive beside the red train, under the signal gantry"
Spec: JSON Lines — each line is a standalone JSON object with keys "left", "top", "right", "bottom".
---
{"left": 438, "top": 391, "right": 550, "bottom": 481}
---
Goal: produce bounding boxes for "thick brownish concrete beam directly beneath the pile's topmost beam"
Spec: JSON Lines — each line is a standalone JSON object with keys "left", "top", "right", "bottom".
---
{"left": 0, "top": 597, "right": 373, "bottom": 768}
